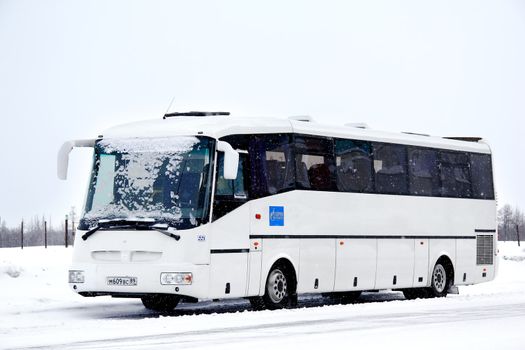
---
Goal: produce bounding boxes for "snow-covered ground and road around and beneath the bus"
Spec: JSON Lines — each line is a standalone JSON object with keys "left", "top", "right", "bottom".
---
{"left": 0, "top": 242, "right": 525, "bottom": 350}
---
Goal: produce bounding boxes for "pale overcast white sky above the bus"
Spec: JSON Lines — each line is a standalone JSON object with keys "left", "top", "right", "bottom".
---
{"left": 0, "top": 0, "right": 525, "bottom": 226}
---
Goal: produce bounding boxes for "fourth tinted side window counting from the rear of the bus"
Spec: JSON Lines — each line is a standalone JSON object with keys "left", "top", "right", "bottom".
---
{"left": 373, "top": 143, "right": 408, "bottom": 194}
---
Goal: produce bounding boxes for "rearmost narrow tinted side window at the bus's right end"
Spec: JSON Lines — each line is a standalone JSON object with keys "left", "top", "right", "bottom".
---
{"left": 470, "top": 153, "right": 494, "bottom": 199}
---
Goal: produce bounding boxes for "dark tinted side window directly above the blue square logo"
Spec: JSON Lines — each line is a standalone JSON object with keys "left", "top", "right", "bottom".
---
{"left": 249, "top": 134, "right": 295, "bottom": 198}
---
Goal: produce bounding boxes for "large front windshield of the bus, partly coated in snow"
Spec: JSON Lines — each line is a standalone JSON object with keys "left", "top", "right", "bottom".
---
{"left": 79, "top": 137, "right": 214, "bottom": 229}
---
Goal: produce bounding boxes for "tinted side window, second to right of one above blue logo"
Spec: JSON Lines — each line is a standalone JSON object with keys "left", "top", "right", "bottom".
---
{"left": 335, "top": 139, "right": 372, "bottom": 192}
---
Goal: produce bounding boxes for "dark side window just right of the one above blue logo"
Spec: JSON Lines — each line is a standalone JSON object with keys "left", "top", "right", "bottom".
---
{"left": 295, "top": 136, "right": 336, "bottom": 191}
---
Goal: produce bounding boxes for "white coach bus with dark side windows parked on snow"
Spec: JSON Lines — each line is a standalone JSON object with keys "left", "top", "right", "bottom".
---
{"left": 58, "top": 112, "right": 497, "bottom": 311}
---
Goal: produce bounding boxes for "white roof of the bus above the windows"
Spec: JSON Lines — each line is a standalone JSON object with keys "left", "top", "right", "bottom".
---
{"left": 102, "top": 115, "right": 490, "bottom": 153}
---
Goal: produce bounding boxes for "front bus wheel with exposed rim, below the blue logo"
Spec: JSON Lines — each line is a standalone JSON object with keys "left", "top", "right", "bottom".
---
{"left": 260, "top": 264, "right": 297, "bottom": 310}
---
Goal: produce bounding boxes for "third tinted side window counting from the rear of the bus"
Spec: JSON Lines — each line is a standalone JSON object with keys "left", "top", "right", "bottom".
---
{"left": 408, "top": 147, "right": 440, "bottom": 196}
